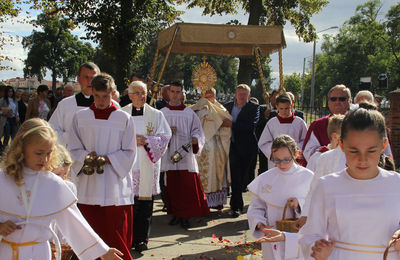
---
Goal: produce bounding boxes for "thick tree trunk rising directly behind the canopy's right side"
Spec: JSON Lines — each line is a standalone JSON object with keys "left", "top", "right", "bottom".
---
{"left": 237, "top": 0, "right": 263, "bottom": 85}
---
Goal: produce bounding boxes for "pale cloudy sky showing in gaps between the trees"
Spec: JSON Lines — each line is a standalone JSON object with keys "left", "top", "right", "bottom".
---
{"left": 0, "top": 0, "right": 397, "bottom": 84}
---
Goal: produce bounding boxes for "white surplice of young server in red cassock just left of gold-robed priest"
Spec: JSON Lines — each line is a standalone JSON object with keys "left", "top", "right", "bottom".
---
{"left": 161, "top": 107, "right": 205, "bottom": 172}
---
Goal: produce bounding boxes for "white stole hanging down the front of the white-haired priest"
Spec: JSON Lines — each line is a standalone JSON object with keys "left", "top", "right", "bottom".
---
{"left": 139, "top": 104, "right": 159, "bottom": 200}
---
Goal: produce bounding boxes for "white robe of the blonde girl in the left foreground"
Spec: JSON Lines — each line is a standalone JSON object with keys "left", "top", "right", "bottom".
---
{"left": 0, "top": 168, "right": 109, "bottom": 260}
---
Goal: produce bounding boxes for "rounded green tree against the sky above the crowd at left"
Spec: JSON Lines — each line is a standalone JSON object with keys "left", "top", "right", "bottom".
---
{"left": 22, "top": 14, "right": 93, "bottom": 91}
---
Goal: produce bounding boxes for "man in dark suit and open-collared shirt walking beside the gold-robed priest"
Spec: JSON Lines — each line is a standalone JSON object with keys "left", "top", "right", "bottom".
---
{"left": 225, "top": 84, "right": 260, "bottom": 217}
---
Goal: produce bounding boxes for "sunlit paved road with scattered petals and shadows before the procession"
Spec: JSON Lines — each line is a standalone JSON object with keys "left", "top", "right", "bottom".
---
{"left": 132, "top": 192, "right": 262, "bottom": 260}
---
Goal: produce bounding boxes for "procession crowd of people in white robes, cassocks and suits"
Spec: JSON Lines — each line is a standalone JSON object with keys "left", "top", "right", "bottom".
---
{"left": 0, "top": 62, "right": 400, "bottom": 259}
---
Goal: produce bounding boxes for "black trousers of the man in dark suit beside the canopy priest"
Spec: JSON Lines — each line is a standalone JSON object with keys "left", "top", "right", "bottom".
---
{"left": 229, "top": 147, "right": 257, "bottom": 211}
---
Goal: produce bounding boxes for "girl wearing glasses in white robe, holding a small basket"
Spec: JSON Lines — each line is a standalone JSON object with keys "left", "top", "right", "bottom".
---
{"left": 247, "top": 135, "right": 314, "bottom": 260}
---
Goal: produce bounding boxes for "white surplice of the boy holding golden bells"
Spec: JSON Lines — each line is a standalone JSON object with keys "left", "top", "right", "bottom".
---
{"left": 68, "top": 108, "right": 136, "bottom": 206}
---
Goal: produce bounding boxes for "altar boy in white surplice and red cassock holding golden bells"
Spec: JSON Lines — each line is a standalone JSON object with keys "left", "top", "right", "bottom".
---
{"left": 68, "top": 73, "right": 136, "bottom": 259}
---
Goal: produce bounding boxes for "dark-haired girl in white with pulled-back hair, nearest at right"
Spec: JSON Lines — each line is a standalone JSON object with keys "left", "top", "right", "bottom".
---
{"left": 300, "top": 108, "right": 400, "bottom": 260}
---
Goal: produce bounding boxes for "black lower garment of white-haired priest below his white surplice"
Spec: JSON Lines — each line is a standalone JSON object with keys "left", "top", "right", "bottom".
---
{"left": 132, "top": 197, "right": 154, "bottom": 246}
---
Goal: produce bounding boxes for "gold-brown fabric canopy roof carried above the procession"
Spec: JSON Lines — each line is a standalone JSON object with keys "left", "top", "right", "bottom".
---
{"left": 158, "top": 23, "right": 286, "bottom": 57}
